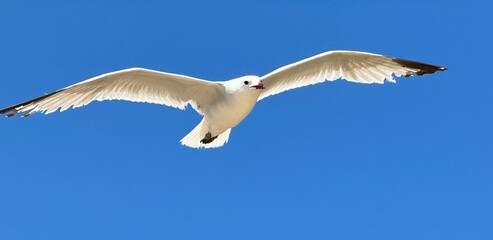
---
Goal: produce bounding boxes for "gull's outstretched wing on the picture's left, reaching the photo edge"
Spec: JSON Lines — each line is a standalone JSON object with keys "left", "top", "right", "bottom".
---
{"left": 0, "top": 68, "right": 224, "bottom": 117}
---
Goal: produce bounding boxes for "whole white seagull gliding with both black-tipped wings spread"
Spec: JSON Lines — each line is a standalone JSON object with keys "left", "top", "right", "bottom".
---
{"left": 0, "top": 51, "right": 447, "bottom": 148}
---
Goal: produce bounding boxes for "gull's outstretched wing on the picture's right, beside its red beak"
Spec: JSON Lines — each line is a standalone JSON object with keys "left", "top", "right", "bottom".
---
{"left": 258, "top": 51, "right": 447, "bottom": 101}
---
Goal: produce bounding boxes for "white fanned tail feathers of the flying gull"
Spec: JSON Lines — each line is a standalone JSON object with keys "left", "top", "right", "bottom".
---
{"left": 180, "top": 119, "right": 231, "bottom": 148}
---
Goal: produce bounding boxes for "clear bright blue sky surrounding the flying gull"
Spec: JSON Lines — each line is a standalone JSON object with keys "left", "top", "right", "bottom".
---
{"left": 0, "top": 1, "right": 493, "bottom": 240}
